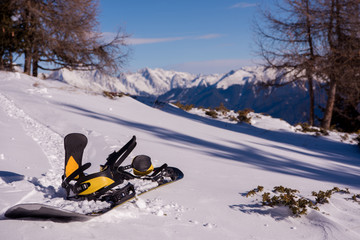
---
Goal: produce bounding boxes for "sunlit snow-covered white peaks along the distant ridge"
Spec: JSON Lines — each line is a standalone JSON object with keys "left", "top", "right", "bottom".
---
{"left": 49, "top": 68, "right": 270, "bottom": 96}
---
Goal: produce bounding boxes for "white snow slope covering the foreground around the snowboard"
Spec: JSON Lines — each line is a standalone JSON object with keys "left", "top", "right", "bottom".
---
{"left": 0, "top": 72, "right": 360, "bottom": 240}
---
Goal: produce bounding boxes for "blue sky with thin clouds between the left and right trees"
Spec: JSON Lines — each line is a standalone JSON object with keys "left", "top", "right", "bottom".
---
{"left": 99, "top": 0, "right": 264, "bottom": 74}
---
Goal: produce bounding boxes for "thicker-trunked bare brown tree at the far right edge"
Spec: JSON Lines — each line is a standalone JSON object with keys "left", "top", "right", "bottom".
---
{"left": 320, "top": 0, "right": 360, "bottom": 129}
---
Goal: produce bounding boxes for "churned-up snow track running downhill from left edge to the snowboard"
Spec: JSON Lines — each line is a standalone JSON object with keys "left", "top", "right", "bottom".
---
{"left": 0, "top": 93, "right": 120, "bottom": 213}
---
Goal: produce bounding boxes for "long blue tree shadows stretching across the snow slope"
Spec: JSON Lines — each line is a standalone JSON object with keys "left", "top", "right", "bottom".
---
{"left": 58, "top": 102, "right": 360, "bottom": 187}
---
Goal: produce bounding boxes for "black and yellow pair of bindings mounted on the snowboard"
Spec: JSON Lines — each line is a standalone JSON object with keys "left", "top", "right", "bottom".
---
{"left": 62, "top": 133, "right": 177, "bottom": 205}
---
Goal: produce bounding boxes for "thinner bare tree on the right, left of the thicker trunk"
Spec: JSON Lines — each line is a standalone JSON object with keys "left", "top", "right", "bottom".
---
{"left": 256, "top": 0, "right": 319, "bottom": 125}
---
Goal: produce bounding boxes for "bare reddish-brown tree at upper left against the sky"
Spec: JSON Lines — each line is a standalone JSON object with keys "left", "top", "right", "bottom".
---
{"left": 0, "top": 0, "right": 128, "bottom": 76}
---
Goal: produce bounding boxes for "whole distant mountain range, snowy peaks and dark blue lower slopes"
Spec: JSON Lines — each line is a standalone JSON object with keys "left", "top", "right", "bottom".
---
{"left": 48, "top": 67, "right": 325, "bottom": 124}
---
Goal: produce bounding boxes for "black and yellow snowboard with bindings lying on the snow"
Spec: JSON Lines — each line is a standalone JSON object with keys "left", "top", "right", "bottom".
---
{"left": 5, "top": 133, "right": 184, "bottom": 221}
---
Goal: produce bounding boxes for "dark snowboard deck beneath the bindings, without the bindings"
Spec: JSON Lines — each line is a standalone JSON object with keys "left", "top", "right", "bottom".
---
{"left": 5, "top": 167, "right": 184, "bottom": 222}
